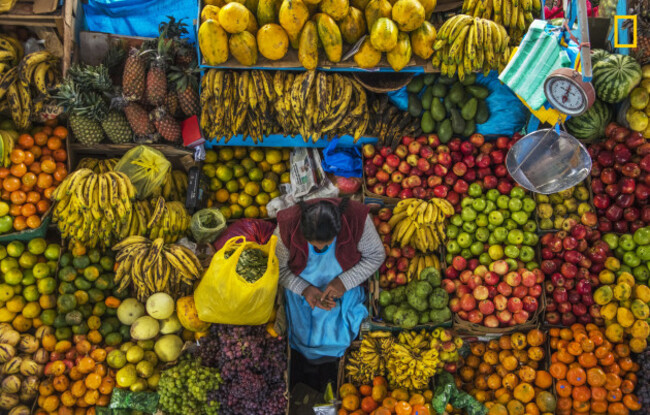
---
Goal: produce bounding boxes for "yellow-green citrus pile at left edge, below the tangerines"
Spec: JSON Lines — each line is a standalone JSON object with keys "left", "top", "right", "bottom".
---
{"left": 0, "top": 238, "right": 61, "bottom": 333}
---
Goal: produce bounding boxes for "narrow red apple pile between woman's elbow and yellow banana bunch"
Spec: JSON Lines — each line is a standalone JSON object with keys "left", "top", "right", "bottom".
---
{"left": 372, "top": 208, "right": 416, "bottom": 288}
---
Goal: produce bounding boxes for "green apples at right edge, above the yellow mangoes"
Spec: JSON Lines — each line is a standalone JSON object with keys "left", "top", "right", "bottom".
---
{"left": 603, "top": 226, "right": 650, "bottom": 285}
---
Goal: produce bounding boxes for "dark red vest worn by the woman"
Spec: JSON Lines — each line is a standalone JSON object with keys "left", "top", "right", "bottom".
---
{"left": 277, "top": 199, "right": 370, "bottom": 275}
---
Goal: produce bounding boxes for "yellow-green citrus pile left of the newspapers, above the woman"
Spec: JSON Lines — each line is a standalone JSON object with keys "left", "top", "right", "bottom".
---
{"left": 203, "top": 147, "right": 290, "bottom": 219}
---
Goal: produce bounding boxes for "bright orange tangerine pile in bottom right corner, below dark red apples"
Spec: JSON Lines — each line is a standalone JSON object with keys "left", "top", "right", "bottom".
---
{"left": 549, "top": 324, "right": 641, "bottom": 415}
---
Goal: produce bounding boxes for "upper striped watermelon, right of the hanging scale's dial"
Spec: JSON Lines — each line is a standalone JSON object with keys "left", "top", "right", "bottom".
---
{"left": 593, "top": 54, "right": 641, "bottom": 104}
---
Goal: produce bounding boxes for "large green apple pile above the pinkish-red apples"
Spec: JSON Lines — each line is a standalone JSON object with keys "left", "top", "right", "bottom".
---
{"left": 446, "top": 184, "right": 539, "bottom": 269}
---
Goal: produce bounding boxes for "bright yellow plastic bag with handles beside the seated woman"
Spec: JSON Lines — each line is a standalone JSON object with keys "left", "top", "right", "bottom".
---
{"left": 194, "top": 235, "right": 280, "bottom": 326}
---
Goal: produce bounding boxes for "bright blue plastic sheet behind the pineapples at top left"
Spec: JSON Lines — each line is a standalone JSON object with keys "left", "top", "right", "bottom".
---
{"left": 83, "top": 0, "right": 199, "bottom": 43}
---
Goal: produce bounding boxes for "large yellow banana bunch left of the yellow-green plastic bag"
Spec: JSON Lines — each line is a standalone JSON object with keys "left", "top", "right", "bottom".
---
{"left": 52, "top": 169, "right": 135, "bottom": 248}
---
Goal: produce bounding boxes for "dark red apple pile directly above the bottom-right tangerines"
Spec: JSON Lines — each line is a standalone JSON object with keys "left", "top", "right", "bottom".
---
{"left": 541, "top": 224, "right": 611, "bottom": 326}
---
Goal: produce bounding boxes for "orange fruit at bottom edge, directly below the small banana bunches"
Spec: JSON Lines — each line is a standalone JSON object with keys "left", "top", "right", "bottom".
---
{"left": 338, "top": 376, "right": 435, "bottom": 415}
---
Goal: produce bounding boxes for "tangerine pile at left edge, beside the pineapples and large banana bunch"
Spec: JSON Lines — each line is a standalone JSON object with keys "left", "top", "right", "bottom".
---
{"left": 0, "top": 120, "right": 68, "bottom": 233}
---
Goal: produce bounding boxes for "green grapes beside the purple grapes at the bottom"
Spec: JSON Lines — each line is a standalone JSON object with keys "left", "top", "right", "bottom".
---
{"left": 158, "top": 355, "right": 222, "bottom": 415}
